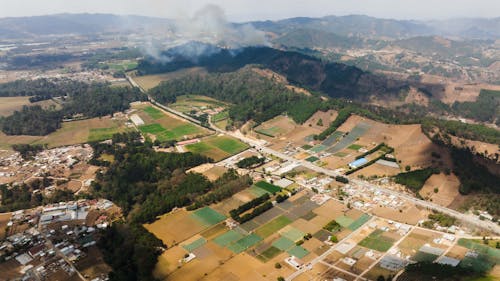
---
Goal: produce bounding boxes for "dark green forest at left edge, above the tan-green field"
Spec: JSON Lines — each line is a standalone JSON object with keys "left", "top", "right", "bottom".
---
{"left": 0, "top": 80, "right": 146, "bottom": 136}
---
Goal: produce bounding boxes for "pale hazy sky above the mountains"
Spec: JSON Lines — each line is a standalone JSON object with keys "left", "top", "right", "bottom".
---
{"left": 0, "top": 0, "right": 500, "bottom": 21}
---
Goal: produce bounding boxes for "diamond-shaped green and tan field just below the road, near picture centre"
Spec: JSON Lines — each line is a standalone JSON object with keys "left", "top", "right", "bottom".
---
{"left": 186, "top": 136, "right": 248, "bottom": 161}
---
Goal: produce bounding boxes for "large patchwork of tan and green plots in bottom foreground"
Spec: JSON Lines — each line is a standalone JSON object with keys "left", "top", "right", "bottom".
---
{"left": 145, "top": 182, "right": 376, "bottom": 280}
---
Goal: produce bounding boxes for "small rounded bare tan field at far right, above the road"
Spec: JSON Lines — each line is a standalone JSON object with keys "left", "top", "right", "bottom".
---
{"left": 419, "top": 173, "right": 460, "bottom": 206}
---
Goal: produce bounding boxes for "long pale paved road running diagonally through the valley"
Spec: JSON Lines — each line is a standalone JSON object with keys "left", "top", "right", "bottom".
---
{"left": 127, "top": 74, "right": 500, "bottom": 234}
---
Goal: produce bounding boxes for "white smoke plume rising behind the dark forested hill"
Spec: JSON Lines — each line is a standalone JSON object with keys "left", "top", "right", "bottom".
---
{"left": 137, "top": 4, "right": 270, "bottom": 63}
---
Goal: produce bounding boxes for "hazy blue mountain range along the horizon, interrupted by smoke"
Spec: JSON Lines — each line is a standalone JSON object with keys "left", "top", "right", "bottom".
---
{"left": 0, "top": 14, "right": 500, "bottom": 40}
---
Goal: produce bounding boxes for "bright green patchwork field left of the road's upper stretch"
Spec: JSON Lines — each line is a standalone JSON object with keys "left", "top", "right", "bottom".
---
{"left": 132, "top": 103, "right": 210, "bottom": 142}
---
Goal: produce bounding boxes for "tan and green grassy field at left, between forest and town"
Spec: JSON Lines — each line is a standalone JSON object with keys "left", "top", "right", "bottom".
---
{"left": 0, "top": 117, "right": 130, "bottom": 149}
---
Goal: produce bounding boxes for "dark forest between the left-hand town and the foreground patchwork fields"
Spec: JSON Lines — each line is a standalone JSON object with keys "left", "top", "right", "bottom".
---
{"left": 88, "top": 132, "right": 252, "bottom": 280}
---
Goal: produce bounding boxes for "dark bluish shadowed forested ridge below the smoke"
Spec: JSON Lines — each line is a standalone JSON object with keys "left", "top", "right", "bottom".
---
{"left": 138, "top": 44, "right": 408, "bottom": 100}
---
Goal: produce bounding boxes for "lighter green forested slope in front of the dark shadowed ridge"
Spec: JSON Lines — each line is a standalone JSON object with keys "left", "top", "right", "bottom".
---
{"left": 149, "top": 68, "right": 323, "bottom": 124}
